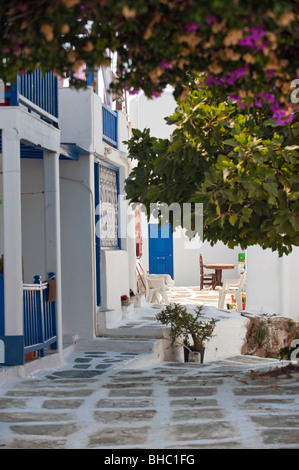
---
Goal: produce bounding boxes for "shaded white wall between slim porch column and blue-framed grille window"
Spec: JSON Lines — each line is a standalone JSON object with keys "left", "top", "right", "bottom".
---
{"left": 60, "top": 155, "right": 95, "bottom": 338}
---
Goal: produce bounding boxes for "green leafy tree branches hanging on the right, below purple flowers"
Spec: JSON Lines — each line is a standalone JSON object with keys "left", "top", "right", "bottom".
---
{"left": 126, "top": 77, "right": 299, "bottom": 255}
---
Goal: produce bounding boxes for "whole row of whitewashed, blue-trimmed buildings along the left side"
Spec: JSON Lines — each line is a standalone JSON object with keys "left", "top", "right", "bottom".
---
{"left": 0, "top": 67, "right": 136, "bottom": 366}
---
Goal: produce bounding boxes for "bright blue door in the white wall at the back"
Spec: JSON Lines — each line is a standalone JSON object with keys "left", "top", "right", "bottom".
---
{"left": 149, "top": 224, "right": 173, "bottom": 279}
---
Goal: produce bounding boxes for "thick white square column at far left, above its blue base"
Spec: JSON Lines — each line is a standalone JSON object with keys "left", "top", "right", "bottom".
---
{"left": 2, "top": 129, "right": 23, "bottom": 336}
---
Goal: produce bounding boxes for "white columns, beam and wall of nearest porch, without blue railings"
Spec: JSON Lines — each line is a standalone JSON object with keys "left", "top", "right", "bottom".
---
{"left": 0, "top": 106, "right": 62, "bottom": 353}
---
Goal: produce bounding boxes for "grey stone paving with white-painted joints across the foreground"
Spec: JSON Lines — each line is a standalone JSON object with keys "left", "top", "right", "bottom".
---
{"left": 0, "top": 350, "right": 299, "bottom": 450}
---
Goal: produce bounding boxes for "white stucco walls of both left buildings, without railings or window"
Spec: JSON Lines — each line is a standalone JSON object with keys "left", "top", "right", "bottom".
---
{"left": 0, "top": 80, "right": 136, "bottom": 368}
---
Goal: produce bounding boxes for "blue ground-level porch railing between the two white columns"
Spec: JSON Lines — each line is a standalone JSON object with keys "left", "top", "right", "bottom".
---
{"left": 23, "top": 273, "right": 57, "bottom": 357}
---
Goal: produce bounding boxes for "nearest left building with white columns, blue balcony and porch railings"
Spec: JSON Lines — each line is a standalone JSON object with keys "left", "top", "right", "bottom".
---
{"left": 0, "top": 71, "right": 62, "bottom": 365}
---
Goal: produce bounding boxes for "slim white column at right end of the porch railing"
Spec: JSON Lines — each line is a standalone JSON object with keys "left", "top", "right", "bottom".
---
{"left": 43, "top": 152, "right": 63, "bottom": 354}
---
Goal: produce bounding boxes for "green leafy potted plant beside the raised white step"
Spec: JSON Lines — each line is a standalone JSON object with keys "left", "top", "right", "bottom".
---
{"left": 156, "top": 304, "right": 217, "bottom": 363}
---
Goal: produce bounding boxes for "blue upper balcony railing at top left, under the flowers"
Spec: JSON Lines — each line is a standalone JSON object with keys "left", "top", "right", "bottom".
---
{"left": 1, "top": 70, "right": 58, "bottom": 124}
